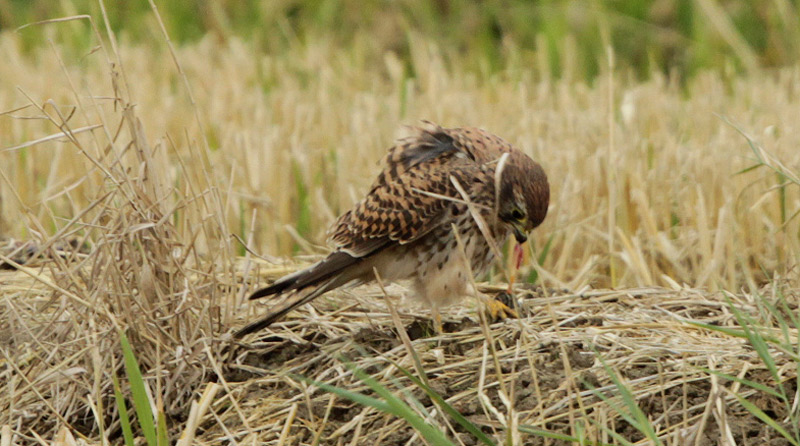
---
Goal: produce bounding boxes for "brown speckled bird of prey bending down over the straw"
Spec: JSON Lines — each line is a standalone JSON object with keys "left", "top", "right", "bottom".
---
{"left": 235, "top": 121, "right": 550, "bottom": 338}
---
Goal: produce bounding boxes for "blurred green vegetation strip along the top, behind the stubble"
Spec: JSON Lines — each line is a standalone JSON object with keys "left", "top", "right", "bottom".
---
{"left": 6, "top": 0, "right": 800, "bottom": 80}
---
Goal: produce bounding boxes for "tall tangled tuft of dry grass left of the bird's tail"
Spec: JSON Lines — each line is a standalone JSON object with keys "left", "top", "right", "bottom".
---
{"left": 0, "top": 13, "right": 233, "bottom": 444}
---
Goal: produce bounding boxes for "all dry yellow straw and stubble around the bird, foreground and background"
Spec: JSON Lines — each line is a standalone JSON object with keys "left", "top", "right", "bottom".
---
{"left": 0, "top": 12, "right": 800, "bottom": 445}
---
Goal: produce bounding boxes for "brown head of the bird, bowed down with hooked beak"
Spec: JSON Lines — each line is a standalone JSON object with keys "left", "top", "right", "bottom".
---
{"left": 496, "top": 150, "right": 550, "bottom": 243}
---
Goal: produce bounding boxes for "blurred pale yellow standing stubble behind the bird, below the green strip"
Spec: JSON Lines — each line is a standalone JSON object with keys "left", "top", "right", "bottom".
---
{"left": 0, "top": 28, "right": 800, "bottom": 289}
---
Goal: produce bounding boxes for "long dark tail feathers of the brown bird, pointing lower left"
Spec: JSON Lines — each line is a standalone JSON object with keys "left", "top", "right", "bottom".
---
{"left": 235, "top": 251, "right": 362, "bottom": 338}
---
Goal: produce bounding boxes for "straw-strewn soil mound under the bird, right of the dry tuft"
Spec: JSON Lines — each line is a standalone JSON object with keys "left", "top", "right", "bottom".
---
{"left": 225, "top": 274, "right": 797, "bottom": 445}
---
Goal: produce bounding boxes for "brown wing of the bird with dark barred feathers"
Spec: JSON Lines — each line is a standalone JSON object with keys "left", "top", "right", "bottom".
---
{"left": 330, "top": 127, "right": 494, "bottom": 257}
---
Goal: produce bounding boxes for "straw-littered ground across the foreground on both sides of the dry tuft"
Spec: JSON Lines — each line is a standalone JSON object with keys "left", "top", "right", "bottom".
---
{"left": 0, "top": 253, "right": 798, "bottom": 446}
